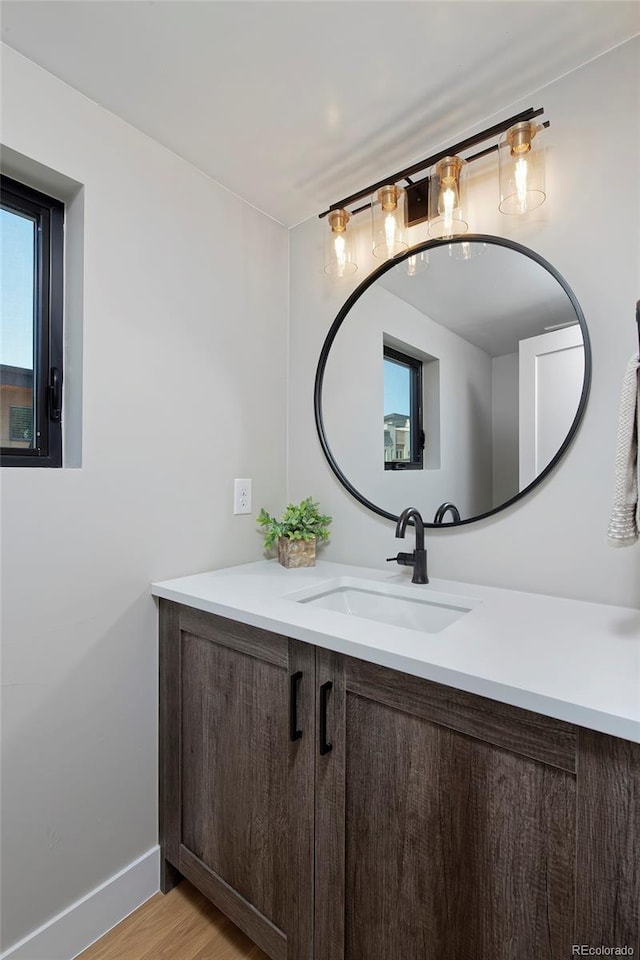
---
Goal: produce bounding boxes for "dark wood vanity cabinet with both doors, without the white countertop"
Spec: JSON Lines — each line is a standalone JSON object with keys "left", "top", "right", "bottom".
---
{"left": 161, "top": 601, "right": 640, "bottom": 960}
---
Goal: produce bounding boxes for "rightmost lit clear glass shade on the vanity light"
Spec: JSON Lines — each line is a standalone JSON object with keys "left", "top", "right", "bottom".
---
{"left": 498, "top": 121, "right": 547, "bottom": 214}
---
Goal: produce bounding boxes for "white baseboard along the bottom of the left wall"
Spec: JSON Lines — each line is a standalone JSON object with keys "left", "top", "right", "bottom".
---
{"left": 0, "top": 846, "right": 160, "bottom": 960}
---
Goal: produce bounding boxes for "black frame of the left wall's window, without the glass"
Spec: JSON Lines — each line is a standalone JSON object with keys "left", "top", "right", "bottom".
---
{"left": 0, "top": 174, "right": 64, "bottom": 467}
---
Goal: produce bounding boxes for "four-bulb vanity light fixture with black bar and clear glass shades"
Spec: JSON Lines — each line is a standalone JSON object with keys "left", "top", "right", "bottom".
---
{"left": 320, "top": 107, "right": 549, "bottom": 277}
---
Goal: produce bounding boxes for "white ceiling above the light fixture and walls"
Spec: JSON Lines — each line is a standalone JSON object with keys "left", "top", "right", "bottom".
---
{"left": 0, "top": 0, "right": 640, "bottom": 226}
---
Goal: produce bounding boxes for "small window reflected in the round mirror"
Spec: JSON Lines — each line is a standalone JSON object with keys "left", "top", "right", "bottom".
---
{"left": 383, "top": 344, "right": 424, "bottom": 470}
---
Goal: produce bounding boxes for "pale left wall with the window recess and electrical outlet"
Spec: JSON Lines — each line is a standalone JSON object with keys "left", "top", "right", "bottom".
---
{"left": 2, "top": 48, "right": 288, "bottom": 947}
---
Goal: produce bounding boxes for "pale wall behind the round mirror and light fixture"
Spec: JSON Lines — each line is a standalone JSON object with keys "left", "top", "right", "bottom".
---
{"left": 289, "top": 38, "right": 640, "bottom": 607}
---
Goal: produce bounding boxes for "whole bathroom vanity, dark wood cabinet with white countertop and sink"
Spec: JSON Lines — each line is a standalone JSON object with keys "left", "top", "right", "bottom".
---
{"left": 153, "top": 561, "right": 640, "bottom": 960}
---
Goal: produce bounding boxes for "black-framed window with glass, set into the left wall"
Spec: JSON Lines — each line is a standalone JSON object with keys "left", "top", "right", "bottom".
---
{"left": 0, "top": 176, "right": 64, "bottom": 467}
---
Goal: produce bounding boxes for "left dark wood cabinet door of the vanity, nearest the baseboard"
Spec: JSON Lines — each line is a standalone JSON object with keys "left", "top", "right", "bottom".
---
{"left": 161, "top": 601, "right": 315, "bottom": 960}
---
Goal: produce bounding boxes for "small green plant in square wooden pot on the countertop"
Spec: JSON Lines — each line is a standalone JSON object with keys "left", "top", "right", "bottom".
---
{"left": 258, "top": 497, "right": 331, "bottom": 567}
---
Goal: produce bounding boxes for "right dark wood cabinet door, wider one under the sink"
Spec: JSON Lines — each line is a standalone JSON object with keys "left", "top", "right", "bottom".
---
{"left": 316, "top": 651, "right": 576, "bottom": 960}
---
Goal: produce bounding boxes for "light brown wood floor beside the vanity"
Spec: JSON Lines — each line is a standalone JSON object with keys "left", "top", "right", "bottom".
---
{"left": 76, "top": 880, "right": 268, "bottom": 960}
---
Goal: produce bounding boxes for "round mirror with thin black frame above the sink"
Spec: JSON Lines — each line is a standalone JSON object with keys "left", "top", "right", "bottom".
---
{"left": 314, "top": 235, "right": 591, "bottom": 526}
